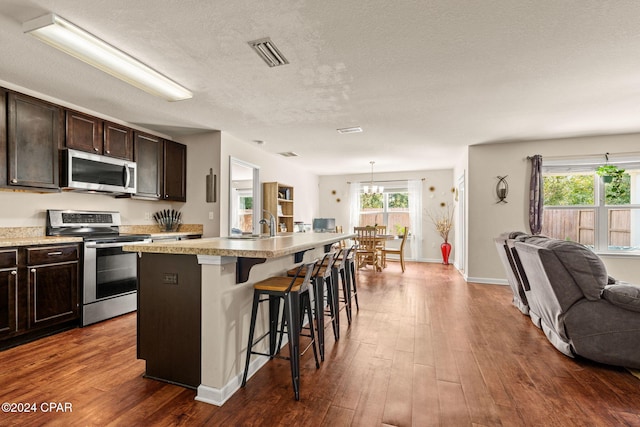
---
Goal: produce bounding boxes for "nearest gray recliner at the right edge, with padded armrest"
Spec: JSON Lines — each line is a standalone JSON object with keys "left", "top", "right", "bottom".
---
{"left": 498, "top": 233, "right": 640, "bottom": 369}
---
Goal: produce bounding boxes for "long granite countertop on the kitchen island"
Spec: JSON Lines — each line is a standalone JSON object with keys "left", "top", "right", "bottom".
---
{"left": 123, "top": 233, "right": 355, "bottom": 258}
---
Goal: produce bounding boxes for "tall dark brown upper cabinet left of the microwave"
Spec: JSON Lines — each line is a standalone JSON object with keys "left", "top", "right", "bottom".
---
{"left": 5, "top": 92, "right": 64, "bottom": 190}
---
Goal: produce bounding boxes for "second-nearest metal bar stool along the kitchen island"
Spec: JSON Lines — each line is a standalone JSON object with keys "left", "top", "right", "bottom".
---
{"left": 287, "top": 248, "right": 340, "bottom": 361}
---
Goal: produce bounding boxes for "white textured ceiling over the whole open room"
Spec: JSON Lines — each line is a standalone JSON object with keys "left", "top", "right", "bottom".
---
{"left": 0, "top": 0, "right": 640, "bottom": 174}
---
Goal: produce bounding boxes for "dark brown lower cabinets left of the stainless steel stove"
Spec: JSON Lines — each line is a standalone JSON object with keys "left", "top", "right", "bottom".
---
{"left": 0, "top": 244, "right": 80, "bottom": 349}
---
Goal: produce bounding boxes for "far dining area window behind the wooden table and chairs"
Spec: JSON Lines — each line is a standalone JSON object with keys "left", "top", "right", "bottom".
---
{"left": 358, "top": 187, "right": 411, "bottom": 235}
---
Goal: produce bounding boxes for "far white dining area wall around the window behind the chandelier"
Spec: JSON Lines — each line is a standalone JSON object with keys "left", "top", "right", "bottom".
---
{"left": 319, "top": 169, "right": 455, "bottom": 262}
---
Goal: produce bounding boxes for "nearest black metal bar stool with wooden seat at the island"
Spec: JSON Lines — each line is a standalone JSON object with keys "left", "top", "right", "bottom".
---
{"left": 242, "top": 260, "right": 320, "bottom": 400}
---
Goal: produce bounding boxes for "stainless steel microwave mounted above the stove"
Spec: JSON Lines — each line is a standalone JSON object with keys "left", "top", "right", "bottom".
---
{"left": 61, "top": 149, "right": 138, "bottom": 194}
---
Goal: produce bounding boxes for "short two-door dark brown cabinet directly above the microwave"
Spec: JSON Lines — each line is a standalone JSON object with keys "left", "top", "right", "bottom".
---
{"left": 66, "top": 110, "right": 133, "bottom": 160}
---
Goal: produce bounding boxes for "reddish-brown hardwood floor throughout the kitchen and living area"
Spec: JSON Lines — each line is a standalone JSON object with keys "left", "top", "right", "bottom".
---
{"left": 0, "top": 263, "right": 640, "bottom": 426}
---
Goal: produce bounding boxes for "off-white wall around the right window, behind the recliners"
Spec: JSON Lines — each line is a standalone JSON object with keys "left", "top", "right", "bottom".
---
{"left": 467, "top": 134, "right": 640, "bottom": 283}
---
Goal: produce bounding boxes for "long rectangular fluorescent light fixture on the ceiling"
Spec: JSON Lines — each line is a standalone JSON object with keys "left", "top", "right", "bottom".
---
{"left": 22, "top": 13, "right": 193, "bottom": 101}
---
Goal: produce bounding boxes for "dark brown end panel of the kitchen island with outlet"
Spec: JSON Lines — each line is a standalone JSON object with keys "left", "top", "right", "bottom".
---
{"left": 138, "top": 253, "right": 201, "bottom": 388}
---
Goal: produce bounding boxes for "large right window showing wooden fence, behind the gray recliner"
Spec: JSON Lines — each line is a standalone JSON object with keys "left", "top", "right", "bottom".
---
{"left": 542, "top": 154, "right": 640, "bottom": 253}
